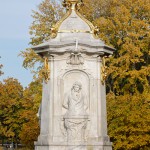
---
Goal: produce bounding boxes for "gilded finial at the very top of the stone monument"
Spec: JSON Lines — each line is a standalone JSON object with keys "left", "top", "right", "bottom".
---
{"left": 62, "top": 0, "right": 83, "bottom": 10}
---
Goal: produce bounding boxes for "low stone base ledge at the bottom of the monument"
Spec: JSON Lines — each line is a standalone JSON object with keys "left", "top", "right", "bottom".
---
{"left": 35, "top": 142, "right": 112, "bottom": 150}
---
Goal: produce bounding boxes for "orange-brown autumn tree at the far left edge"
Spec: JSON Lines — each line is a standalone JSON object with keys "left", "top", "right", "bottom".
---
{"left": 0, "top": 78, "right": 23, "bottom": 143}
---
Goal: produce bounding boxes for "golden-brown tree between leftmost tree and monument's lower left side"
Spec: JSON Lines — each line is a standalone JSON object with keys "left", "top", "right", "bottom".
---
{"left": 19, "top": 80, "right": 42, "bottom": 147}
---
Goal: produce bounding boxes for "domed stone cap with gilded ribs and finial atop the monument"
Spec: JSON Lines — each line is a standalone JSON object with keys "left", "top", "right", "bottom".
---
{"left": 51, "top": 0, "right": 99, "bottom": 38}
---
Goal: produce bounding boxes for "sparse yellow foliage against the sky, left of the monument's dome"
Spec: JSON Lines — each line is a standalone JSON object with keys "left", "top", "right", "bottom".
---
{"left": 20, "top": 0, "right": 64, "bottom": 78}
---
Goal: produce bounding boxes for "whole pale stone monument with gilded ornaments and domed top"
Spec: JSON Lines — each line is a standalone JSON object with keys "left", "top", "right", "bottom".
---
{"left": 33, "top": 0, "right": 115, "bottom": 150}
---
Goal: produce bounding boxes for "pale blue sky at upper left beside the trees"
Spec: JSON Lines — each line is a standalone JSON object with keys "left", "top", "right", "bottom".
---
{"left": 0, "top": 0, "right": 42, "bottom": 87}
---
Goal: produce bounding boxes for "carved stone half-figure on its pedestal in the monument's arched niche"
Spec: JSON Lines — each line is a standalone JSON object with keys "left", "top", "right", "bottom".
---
{"left": 63, "top": 82, "right": 88, "bottom": 141}
